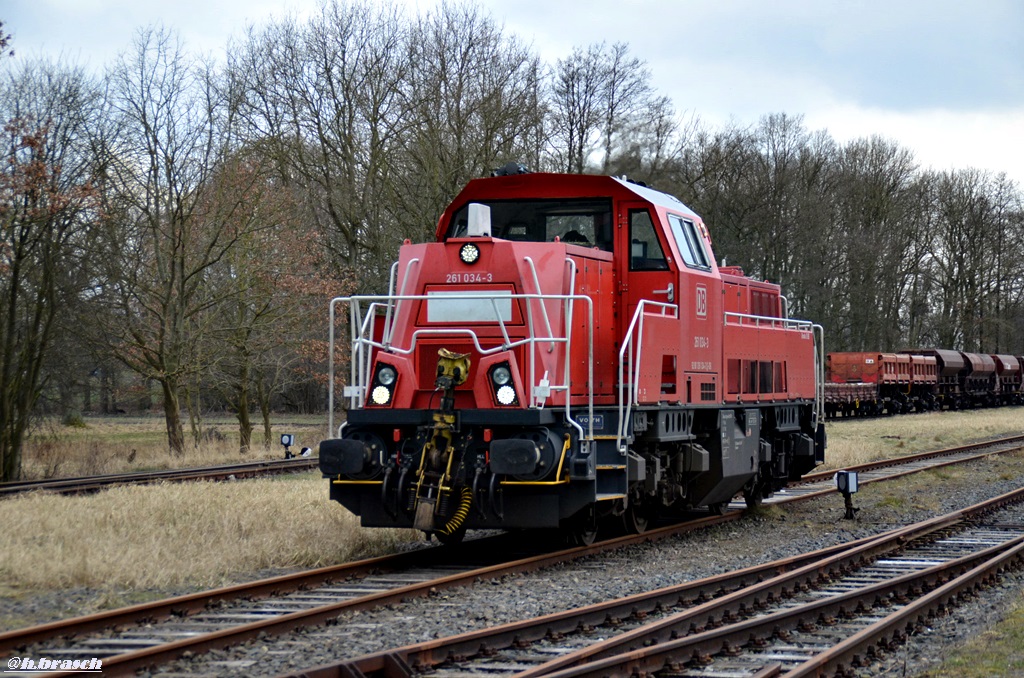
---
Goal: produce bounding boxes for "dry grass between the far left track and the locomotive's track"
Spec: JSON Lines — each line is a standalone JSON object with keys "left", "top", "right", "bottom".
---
{"left": 0, "top": 474, "right": 418, "bottom": 589}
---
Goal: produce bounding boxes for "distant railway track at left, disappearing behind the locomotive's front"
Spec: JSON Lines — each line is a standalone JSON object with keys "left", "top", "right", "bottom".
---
{"left": 0, "top": 457, "right": 317, "bottom": 498}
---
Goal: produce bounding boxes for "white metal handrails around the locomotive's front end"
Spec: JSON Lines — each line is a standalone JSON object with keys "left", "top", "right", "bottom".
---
{"left": 328, "top": 291, "right": 594, "bottom": 440}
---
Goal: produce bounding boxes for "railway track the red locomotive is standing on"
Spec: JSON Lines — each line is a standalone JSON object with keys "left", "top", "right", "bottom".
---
{"left": 0, "top": 439, "right": 1019, "bottom": 674}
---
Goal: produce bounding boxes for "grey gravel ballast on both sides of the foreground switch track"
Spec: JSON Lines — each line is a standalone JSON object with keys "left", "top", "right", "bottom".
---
{"left": 156, "top": 455, "right": 1024, "bottom": 676}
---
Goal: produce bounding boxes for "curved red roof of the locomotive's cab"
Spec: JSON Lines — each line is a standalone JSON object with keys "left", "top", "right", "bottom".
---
{"left": 437, "top": 172, "right": 701, "bottom": 240}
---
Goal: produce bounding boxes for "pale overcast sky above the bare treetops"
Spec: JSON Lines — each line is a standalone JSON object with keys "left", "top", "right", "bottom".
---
{"left": 8, "top": 0, "right": 1024, "bottom": 185}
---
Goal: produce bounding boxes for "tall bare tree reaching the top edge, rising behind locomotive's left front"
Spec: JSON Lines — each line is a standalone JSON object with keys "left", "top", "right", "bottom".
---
{"left": 231, "top": 0, "right": 412, "bottom": 289}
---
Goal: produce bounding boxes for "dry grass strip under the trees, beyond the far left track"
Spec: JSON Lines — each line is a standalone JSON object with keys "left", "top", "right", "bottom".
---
{"left": 23, "top": 416, "right": 326, "bottom": 479}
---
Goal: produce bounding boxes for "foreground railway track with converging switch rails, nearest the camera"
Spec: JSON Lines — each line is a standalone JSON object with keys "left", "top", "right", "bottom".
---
{"left": 293, "top": 489, "right": 1024, "bottom": 678}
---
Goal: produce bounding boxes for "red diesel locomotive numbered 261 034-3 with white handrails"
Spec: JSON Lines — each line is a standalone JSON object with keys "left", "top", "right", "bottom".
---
{"left": 319, "top": 164, "right": 825, "bottom": 541}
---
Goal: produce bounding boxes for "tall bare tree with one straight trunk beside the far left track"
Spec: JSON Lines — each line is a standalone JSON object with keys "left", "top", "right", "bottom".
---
{"left": 96, "top": 29, "right": 251, "bottom": 454}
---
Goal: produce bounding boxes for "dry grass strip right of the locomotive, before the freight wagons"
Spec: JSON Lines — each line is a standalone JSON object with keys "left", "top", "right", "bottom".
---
{"left": 818, "top": 408, "right": 1024, "bottom": 470}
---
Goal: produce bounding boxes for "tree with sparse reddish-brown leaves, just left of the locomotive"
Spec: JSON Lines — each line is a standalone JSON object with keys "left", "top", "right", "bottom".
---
{"left": 203, "top": 149, "right": 340, "bottom": 454}
